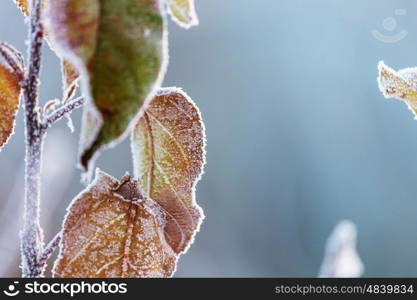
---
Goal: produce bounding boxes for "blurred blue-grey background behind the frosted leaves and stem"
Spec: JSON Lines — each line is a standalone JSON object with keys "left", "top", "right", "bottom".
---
{"left": 0, "top": 0, "right": 417, "bottom": 277}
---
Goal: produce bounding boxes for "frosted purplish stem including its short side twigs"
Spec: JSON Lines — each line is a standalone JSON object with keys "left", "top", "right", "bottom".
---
{"left": 19, "top": 0, "right": 84, "bottom": 278}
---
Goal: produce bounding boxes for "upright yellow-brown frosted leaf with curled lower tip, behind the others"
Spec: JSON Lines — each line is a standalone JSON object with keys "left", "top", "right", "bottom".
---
{"left": 132, "top": 89, "right": 205, "bottom": 253}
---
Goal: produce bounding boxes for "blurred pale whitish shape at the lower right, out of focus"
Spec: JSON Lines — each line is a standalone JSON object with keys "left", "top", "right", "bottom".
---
{"left": 319, "top": 221, "right": 363, "bottom": 277}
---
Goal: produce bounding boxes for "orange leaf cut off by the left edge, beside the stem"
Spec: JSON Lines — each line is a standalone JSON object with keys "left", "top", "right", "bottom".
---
{"left": 0, "top": 63, "right": 20, "bottom": 149}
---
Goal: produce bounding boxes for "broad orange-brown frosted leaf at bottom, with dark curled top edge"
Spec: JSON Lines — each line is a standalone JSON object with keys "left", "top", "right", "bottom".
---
{"left": 53, "top": 171, "right": 177, "bottom": 278}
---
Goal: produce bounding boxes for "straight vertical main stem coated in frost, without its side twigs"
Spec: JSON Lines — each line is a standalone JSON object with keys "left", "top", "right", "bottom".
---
{"left": 21, "top": 0, "right": 44, "bottom": 277}
